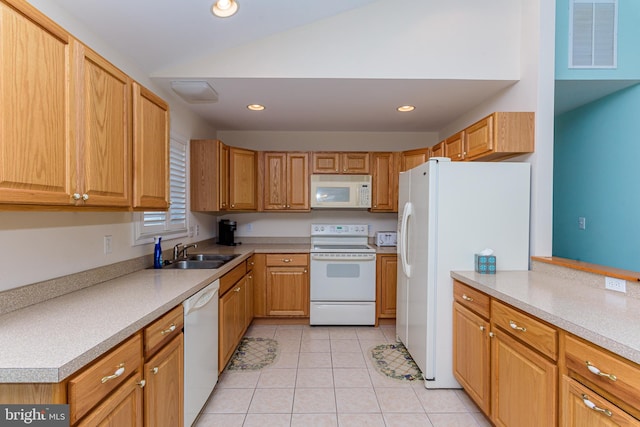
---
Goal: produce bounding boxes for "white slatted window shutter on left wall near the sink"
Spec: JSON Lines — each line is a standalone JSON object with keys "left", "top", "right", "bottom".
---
{"left": 135, "top": 136, "right": 187, "bottom": 243}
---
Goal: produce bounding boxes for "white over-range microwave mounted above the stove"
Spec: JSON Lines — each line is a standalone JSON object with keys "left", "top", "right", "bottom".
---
{"left": 311, "top": 174, "right": 371, "bottom": 208}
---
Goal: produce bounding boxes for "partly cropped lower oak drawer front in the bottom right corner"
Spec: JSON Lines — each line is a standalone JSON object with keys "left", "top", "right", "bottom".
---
{"left": 560, "top": 376, "right": 640, "bottom": 427}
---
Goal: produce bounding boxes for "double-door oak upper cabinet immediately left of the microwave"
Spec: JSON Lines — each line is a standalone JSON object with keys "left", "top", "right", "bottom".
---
{"left": 263, "top": 152, "right": 310, "bottom": 211}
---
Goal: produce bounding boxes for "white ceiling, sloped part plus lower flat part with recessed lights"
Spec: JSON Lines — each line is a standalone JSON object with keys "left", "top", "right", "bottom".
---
{"left": 56, "top": 0, "right": 515, "bottom": 132}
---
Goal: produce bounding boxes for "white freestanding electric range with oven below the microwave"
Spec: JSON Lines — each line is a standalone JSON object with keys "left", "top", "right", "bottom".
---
{"left": 309, "top": 224, "right": 376, "bottom": 325}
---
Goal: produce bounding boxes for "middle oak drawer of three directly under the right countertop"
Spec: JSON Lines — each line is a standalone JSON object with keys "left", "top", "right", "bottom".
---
{"left": 491, "top": 300, "right": 558, "bottom": 360}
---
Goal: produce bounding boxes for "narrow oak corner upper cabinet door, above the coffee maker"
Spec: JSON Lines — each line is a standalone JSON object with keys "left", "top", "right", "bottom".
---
{"left": 229, "top": 147, "right": 257, "bottom": 210}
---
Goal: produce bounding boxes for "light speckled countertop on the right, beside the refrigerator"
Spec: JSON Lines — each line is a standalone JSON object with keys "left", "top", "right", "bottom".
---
{"left": 451, "top": 271, "right": 640, "bottom": 363}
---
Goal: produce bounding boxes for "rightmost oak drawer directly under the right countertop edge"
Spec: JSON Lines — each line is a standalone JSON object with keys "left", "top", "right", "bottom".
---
{"left": 564, "top": 335, "right": 640, "bottom": 408}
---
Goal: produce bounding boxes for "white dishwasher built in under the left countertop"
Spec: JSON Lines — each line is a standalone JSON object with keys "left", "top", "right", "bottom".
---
{"left": 182, "top": 280, "right": 220, "bottom": 427}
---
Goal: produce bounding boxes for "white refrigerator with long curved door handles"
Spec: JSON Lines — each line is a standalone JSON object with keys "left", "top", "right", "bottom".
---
{"left": 396, "top": 158, "right": 531, "bottom": 388}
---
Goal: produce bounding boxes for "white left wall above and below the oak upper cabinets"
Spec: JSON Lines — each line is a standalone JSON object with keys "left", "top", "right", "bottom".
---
{"left": 0, "top": 0, "right": 216, "bottom": 292}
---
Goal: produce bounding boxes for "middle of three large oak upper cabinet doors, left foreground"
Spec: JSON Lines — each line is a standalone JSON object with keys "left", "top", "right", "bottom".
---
{"left": 75, "top": 43, "right": 132, "bottom": 207}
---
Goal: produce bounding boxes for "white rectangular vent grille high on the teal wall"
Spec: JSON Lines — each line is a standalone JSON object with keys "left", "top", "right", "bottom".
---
{"left": 569, "top": 0, "right": 618, "bottom": 68}
